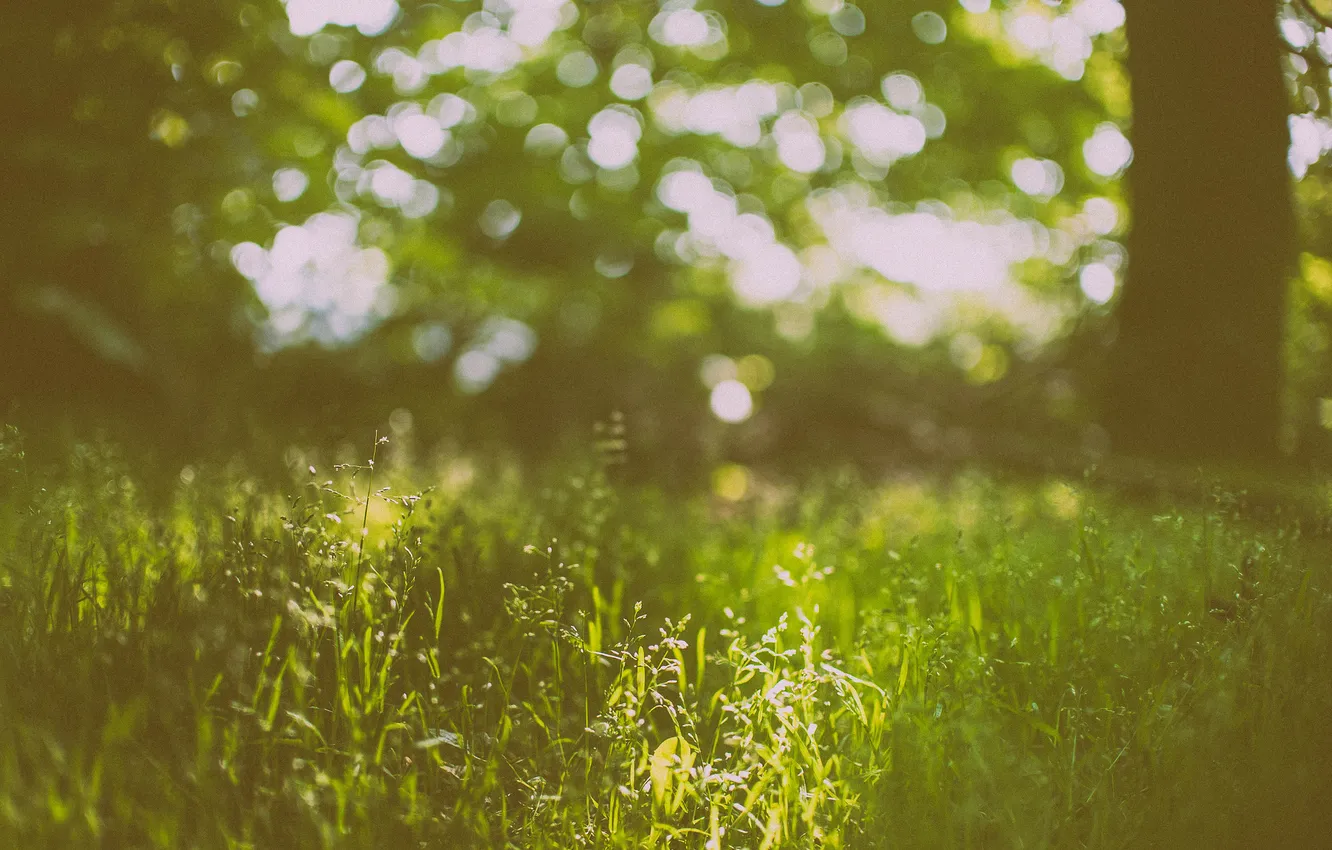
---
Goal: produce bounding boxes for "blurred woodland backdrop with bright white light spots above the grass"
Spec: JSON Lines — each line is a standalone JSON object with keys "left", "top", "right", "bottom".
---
{"left": 0, "top": 0, "right": 1332, "bottom": 479}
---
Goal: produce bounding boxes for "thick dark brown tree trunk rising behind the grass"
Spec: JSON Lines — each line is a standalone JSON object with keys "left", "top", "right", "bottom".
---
{"left": 1106, "top": 0, "right": 1295, "bottom": 462}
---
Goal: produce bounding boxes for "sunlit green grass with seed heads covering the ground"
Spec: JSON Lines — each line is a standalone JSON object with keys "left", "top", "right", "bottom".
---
{"left": 0, "top": 432, "right": 1332, "bottom": 850}
